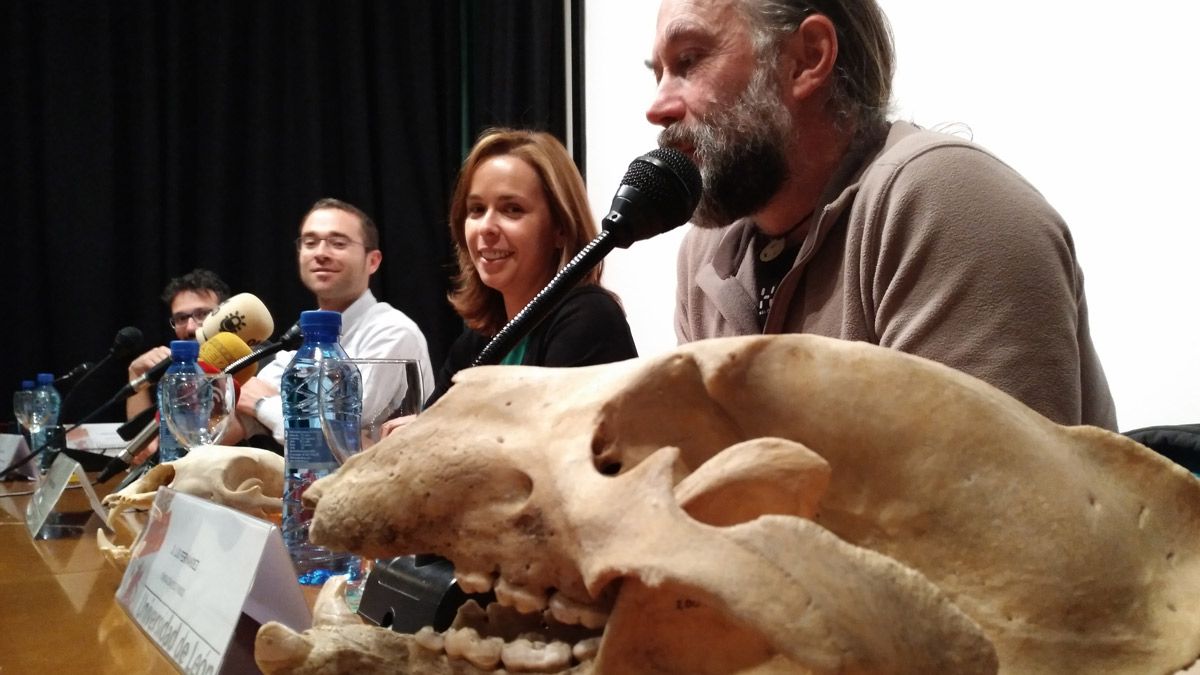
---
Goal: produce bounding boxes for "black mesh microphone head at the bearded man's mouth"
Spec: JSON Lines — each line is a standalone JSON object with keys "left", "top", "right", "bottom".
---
{"left": 602, "top": 148, "right": 702, "bottom": 249}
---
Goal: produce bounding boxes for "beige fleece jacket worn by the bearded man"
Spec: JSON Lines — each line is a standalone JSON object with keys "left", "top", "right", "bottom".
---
{"left": 676, "top": 123, "right": 1116, "bottom": 430}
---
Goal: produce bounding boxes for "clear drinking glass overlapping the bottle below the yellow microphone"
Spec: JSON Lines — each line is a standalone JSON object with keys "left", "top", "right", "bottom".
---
{"left": 158, "top": 372, "right": 235, "bottom": 449}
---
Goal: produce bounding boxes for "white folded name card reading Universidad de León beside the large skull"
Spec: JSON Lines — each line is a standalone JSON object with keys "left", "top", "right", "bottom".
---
{"left": 116, "top": 488, "right": 312, "bottom": 674}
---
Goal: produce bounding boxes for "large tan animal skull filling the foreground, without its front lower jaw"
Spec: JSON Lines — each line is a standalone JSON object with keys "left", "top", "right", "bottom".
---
{"left": 260, "top": 335, "right": 1200, "bottom": 673}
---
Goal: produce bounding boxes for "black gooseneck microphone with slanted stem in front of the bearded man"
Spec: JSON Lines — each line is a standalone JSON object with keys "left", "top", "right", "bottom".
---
{"left": 472, "top": 148, "right": 701, "bottom": 365}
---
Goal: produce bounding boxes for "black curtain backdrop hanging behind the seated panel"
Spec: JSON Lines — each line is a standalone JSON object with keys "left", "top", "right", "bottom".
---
{"left": 0, "top": 0, "right": 582, "bottom": 422}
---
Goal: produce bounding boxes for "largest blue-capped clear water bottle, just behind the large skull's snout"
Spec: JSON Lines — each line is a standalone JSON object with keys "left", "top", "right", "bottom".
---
{"left": 280, "top": 310, "right": 362, "bottom": 585}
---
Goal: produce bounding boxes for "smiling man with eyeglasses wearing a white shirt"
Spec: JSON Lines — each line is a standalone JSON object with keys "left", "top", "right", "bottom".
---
{"left": 231, "top": 198, "right": 433, "bottom": 444}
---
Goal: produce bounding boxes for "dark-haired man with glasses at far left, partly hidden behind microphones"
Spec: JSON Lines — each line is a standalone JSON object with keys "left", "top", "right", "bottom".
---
{"left": 125, "top": 269, "right": 229, "bottom": 419}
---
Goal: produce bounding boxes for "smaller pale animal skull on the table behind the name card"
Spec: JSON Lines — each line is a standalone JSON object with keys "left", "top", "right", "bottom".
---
{"left": 96, "top": 446, "right": 283, "bottom": 568}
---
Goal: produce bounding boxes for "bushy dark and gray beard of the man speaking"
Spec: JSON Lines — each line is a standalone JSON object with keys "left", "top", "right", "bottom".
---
{"left": 659, "top": 66, "right": 793, "bottom": 227}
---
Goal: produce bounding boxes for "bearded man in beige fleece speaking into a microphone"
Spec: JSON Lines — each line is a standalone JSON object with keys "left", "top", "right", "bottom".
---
{"left": 647, "top": 0, "right": 1116, "bottom": 429}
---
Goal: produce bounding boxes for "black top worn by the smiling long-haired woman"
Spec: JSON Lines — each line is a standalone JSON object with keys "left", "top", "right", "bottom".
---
{"left": 425, "top": 285, "right": 637, "bottom": 406}
